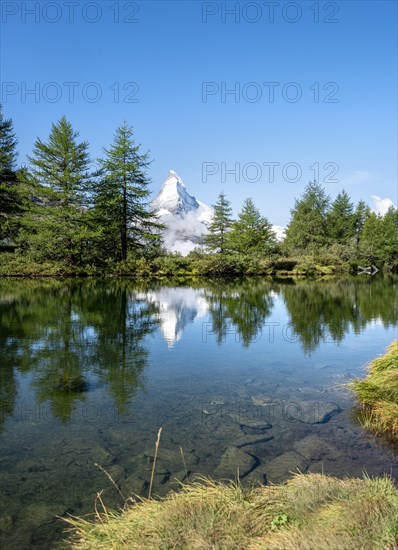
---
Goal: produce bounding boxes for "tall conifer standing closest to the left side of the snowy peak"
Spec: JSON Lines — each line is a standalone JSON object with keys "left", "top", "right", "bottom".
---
{"left": 94, "top": 122, "right": 161, "bottom": 261}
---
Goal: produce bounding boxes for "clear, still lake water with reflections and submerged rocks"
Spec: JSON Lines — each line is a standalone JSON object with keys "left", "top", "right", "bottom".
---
{"left": 0, "top": 276, "right": 398, "bottom": 549}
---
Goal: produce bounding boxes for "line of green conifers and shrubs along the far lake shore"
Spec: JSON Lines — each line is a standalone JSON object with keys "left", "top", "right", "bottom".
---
{"left": 0, "top": 109, "right": 398, "bottom": 276}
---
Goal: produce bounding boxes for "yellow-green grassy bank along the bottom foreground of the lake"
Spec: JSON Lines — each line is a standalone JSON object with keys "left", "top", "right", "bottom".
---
{"left": 66, "top": 474, "right": 398, "bottom": 550}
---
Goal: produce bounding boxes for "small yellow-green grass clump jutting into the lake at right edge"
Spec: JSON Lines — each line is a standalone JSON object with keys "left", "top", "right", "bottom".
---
{"left": 353, "top": 340, "right": 398, "bottom": 443}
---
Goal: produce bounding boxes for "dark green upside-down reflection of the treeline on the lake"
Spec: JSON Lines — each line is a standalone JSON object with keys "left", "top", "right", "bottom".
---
{"left": 0, "top": 275, "right": 398, "bottom": 430}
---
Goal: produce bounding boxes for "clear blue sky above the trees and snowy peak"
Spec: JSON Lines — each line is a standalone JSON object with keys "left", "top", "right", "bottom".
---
{"left": 1, "top": 0, "right": 397, "bottom": 225}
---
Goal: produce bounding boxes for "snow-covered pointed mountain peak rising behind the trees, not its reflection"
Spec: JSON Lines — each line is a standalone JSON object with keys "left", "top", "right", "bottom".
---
{"left": 152, "top": 170, "right": 213, "bottom": 256}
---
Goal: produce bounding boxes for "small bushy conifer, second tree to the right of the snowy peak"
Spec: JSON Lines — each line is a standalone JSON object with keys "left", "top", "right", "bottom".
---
{"left": 227, "top": 198, "right": 276, "bottom": 255}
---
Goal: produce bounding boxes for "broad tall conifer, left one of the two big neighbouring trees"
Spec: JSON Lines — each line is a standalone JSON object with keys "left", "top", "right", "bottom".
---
{"left": 20, "top": 117, "right": 93, "bottom": 265}
